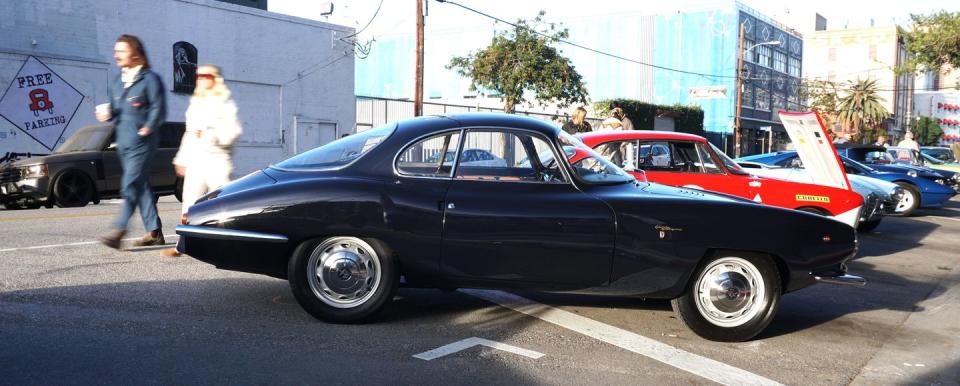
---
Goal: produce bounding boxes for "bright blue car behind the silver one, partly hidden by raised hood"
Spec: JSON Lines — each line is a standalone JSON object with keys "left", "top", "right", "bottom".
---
{"left": 736, "top": 149, "right": 957, "bottom": 216}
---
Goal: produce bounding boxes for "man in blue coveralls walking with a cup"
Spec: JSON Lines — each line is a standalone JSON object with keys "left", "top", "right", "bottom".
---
{"left": 97, "top": 35, "right": 166, "bottom": 249}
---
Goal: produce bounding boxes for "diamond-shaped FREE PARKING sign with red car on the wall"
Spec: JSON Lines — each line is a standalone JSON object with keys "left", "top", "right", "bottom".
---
{"left": 0, "top": 56, "right": 83, "bottom": 151}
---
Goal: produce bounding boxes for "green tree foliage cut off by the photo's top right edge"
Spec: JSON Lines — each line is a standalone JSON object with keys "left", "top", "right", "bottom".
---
{"left": 900, "top": 11, "right": 960, "bottom": 86}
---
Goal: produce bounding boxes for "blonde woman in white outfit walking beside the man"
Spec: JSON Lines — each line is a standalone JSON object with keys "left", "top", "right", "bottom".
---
{"left": 163, "top": 64, "right": 243, "bottom": 257}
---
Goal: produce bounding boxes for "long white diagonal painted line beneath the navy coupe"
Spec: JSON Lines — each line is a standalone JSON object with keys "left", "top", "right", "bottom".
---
{"left": 459, "top": 289, "right": 780, "bottom": 385}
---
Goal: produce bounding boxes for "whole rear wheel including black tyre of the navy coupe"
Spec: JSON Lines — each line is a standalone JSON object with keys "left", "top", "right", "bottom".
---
{"left": 287, "top": 236, "right": 400, "bottom": 323}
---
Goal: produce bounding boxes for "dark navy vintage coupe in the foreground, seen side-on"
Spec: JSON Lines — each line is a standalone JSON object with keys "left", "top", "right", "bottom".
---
{"left": 177, "top": 113, "right": 864, "bottom": 341}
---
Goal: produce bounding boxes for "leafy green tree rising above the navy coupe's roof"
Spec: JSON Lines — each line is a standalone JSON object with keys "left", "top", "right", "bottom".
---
{"left": 447, "top": 11, "right": 587, "bottom": 113}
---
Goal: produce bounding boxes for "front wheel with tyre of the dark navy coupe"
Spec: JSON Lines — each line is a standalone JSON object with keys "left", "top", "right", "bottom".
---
{"left": 671, "top": 252, "right": 781, "bottom": 342}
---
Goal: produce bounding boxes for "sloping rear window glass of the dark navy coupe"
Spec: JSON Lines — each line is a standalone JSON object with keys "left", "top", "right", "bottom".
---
{"left": 274, "top": 124, "right": 396, "bottom": 170}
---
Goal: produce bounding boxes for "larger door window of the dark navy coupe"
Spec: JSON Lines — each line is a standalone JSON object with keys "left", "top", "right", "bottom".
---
{"left": 454, "top": 129, "right": 566, "bottom": 183}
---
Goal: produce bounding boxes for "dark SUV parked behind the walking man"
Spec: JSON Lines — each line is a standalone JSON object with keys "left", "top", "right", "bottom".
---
{"left": 0, "top": 122, "right": 184, "bottom": 209}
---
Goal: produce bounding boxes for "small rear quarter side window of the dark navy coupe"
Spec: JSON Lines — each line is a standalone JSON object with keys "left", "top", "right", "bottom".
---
{"left": 397, "top": 131, "right": 460, "bottom": 177}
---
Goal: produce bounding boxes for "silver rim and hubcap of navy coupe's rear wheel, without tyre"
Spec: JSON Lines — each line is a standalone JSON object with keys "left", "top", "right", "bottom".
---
{"left": 307, "top": 237, "right": 381, "bottom": 308}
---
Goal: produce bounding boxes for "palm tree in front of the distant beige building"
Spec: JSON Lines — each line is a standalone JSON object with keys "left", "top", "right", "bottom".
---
{"left": 838, "top": 78, "right": 890, "bottom": 139}
